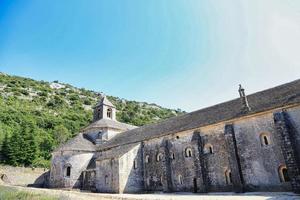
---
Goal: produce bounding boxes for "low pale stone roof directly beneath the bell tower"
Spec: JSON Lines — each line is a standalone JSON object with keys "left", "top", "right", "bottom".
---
{"left": 83, "top": 119, "right": 137, "bottom": 131}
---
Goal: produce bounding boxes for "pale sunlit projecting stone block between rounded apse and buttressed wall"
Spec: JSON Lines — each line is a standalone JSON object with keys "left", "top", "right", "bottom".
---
{"left": 96, "top": 143, "right": 144, "bottom": 193}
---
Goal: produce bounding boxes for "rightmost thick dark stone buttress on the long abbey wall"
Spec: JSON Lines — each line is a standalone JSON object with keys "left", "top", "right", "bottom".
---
{"left": 273, "top": 111, "right": 300, "bottom": 193}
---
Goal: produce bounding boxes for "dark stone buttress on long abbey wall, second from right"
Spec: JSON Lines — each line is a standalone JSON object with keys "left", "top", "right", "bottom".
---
{"left": 224, "top": 124, "right": 244, "bottom": 192}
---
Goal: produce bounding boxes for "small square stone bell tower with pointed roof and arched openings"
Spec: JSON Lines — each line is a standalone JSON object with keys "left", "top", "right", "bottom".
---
{"left": 93, "top": 94, "right": 116, "bottom": 122}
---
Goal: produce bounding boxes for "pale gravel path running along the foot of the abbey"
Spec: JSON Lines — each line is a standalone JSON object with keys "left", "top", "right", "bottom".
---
{"left": 2, "top": 186, "right": 300, "bottom": 200}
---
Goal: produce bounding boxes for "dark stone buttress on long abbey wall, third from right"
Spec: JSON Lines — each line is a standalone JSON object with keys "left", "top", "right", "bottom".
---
{"left": 192, "top": 132, "right": 209, "bottom": 193}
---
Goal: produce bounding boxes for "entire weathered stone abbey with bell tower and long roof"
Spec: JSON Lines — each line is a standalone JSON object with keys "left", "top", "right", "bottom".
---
{"left": 49, "top": 80, "right": 300, "bottom": 193}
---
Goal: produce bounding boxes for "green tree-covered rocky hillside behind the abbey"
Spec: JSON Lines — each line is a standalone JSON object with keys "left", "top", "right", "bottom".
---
{"left": 0, "top": 73, "right": 184, "bottom": 167}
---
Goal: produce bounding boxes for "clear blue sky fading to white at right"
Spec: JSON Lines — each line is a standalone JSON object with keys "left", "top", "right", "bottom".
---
{"left": 0, "top": 0, "right": 300, "bottom": 111}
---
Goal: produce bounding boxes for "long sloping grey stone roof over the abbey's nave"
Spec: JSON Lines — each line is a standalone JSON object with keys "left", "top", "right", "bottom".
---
{"left": 99, "top": 79, "right": 300, "bottom": 150}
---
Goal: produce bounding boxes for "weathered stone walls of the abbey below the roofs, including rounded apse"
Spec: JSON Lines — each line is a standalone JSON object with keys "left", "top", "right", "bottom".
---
{"left": 50, "top": 104, "right": 300, "bottom": 193}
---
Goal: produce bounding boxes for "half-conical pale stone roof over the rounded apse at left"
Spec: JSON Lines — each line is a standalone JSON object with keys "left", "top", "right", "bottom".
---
{"left": 54, "top": 133, "right": 96, "bottom": 152}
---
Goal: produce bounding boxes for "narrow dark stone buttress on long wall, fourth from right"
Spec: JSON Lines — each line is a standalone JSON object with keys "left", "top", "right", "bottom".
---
{"left": 163, "top": 140, "right": 173, "bottom": 192}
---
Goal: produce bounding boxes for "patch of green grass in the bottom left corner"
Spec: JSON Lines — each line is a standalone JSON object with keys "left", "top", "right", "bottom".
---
{"left": 0, "top": 186, "right": 59, "bottom": 200}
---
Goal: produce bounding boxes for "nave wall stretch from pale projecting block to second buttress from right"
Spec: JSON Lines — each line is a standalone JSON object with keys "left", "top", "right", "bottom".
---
{"left": 143, "top": 126, "right": 229, "bottom": 192}
